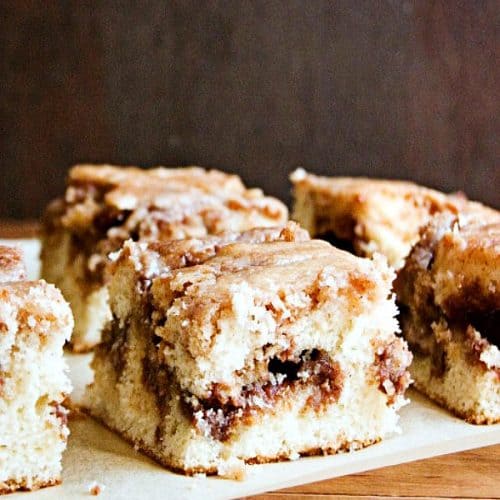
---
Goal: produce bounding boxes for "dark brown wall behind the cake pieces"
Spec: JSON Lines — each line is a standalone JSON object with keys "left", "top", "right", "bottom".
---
{"left": 0, "top": 0, "right": 500, "bottom": 218}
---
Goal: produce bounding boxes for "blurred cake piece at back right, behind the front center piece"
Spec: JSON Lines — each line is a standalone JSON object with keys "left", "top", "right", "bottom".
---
{"left": 291, "top": 169, "right": 495, "bottom": 269}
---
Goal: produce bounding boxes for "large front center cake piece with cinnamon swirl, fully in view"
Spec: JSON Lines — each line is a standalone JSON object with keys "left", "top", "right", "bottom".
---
{"left": 84, "top": 225, "right": 411, "bottom": 477}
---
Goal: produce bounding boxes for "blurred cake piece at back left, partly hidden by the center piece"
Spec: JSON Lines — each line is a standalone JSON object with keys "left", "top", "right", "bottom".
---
{"left": 41, "top": 165, "right": 288, "bottom": 351}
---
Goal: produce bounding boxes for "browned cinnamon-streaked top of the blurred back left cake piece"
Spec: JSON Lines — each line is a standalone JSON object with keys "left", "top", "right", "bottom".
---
{"left": 44, "top": 165, "right": 288, "bottom": 283}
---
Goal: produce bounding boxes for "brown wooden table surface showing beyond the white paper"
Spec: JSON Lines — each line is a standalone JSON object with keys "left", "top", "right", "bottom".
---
{"left": 0, "top": 221, "right": 500, "bottom": 500}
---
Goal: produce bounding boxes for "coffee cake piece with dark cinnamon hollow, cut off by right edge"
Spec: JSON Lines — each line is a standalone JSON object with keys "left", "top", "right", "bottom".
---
{"left": 395, "top": 214, "right": 500, "bottom": 424}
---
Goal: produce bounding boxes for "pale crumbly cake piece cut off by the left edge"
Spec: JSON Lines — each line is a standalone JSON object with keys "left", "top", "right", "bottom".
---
{"left": 0, "top": 247, "right": 73, "bottom": 493}
